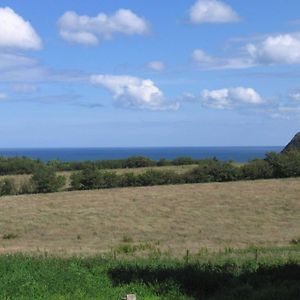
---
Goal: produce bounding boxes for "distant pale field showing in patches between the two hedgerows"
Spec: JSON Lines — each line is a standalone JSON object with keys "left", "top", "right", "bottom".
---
{"left": 0, "top": 165, "right": 197, "bottom": 190}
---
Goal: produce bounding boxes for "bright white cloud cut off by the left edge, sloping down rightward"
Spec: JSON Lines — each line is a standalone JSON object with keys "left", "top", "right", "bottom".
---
{"left": 0, "top": 7, "right": 42, "bottom": 50}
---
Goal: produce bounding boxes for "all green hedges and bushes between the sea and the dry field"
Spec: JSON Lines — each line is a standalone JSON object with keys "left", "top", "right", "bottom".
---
{"left": 0, "top": 151, "right": 300, "bottom": 196}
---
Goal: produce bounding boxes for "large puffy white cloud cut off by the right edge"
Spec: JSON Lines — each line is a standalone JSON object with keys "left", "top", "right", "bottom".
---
{"left": 246, "top": 33, "right": 300, "bottom": 64}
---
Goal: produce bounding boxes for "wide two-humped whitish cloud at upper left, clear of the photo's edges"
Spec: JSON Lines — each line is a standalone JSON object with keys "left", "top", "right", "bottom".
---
{"left": 58, "top": 9, "right": 149, "bottom": 46}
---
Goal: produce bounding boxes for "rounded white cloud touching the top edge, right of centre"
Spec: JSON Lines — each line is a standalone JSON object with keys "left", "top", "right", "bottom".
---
{"left": 189, "top": 0, "right": 240, "bottom": 24}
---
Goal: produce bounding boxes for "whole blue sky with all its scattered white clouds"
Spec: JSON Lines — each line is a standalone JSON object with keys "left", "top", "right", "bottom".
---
{"left": 0, "top": 0, "right": 300, "bottom": 148}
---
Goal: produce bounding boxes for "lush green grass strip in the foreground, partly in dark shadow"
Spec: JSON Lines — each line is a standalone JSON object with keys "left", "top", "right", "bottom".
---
{"left": 0, "top": 246, "right": 300, "bottom": 300}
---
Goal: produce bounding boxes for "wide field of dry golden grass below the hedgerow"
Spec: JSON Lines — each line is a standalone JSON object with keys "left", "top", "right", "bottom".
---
{"left": 0, "top": 179, "right": 300, "bottom": 255}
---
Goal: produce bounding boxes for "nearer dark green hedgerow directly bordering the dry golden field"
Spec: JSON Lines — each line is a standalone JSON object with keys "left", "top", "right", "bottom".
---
{"left": 0, "top": 151, "right": 300, "bottom": 196}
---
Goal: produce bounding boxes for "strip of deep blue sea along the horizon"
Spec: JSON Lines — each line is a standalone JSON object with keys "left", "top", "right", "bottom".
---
{"left": 0, "top": 146, "right": 283, "bottom": 162}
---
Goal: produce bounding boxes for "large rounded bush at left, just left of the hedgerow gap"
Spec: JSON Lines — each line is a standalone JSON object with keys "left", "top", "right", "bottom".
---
{"left": 31, "top": 166, "right": 66, "bottom": 193}
